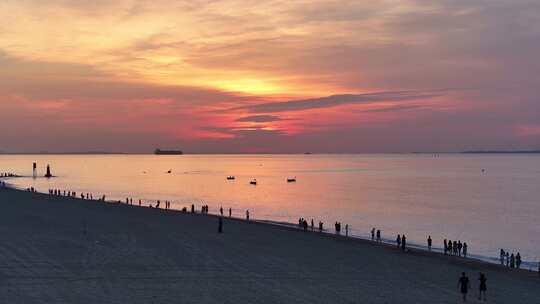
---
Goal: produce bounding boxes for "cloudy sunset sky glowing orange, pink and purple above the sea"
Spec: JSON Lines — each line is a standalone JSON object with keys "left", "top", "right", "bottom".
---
{"left": 0, "top": 0, "right": 540, "bottom": 153}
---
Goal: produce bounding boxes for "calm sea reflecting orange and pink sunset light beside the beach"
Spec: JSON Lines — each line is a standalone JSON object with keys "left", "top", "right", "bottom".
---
{"left": 0, "top": 154, "right": 540, "bottom": 267}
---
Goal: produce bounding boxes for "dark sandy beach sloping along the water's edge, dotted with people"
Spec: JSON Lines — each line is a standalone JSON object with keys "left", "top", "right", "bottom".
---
{"left": 0, "top": 188, "right": 540, "bottom": 303}
